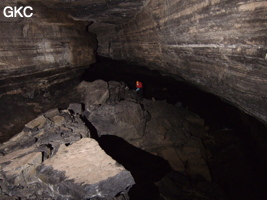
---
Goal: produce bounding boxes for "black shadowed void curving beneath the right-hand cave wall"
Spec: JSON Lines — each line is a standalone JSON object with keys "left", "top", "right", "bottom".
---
{"left": 83, "top": 57, "right": 267, "bottom": 199}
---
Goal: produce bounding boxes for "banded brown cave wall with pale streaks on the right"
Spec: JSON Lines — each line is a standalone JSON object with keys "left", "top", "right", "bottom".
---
{"left": 89, "top": 0, "right": 267, "bottom": 123}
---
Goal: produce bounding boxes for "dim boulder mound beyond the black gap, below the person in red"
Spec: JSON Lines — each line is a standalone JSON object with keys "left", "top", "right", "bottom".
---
{"left": 80, "top": 81, "right": 211, "bottom": 181}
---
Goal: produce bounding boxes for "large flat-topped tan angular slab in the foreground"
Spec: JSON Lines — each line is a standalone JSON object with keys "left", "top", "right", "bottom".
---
{"left": 37, "top": 138, "right": 135, "bottom": 199}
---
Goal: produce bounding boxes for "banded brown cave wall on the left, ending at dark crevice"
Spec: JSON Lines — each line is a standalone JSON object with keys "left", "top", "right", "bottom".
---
{"left": 0, "top": 0, "right": 96, "bottom": 96}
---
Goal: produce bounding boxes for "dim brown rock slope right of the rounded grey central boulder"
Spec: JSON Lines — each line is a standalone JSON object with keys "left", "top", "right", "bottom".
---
{"left": 134, "top": 100, "right": 211, "bottom": 181}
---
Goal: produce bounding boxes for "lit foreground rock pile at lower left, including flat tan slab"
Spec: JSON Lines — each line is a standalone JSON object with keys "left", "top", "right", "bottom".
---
{"left": 0, "top": 106, "right": 134, "bottom": 200}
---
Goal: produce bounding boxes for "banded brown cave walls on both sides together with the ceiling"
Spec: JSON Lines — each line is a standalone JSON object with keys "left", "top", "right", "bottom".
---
{"left": 0, "top": 0, "right": 267, "bottom": 123}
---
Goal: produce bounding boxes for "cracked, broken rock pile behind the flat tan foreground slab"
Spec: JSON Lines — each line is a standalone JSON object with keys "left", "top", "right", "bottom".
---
{"left": 0, "top": 109, "right": 90, "bottom": 154}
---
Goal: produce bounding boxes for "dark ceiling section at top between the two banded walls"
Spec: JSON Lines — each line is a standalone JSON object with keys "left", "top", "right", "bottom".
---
{"left": 20, "top": 0, "right": 147, "bottom": 25}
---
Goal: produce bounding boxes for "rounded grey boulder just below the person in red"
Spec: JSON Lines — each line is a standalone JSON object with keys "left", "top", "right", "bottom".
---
{"left": 89, "top": 101, "right": 148, "bottom": 143}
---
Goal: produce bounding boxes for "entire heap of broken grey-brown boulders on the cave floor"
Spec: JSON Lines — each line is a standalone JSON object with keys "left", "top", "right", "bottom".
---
{"left": 0, "top": 80, "right": 226, "bottom": 200}
